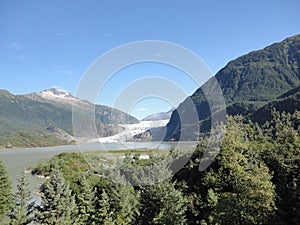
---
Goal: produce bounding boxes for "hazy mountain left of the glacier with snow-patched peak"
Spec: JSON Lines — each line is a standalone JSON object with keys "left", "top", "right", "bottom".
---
{"left": 0, "top": 89, "right": 139, "bottom": 147}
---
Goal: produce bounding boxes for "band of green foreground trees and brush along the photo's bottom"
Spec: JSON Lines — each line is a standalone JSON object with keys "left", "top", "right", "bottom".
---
{"left": 0, "top": 111, "right": 300, "bottom": 225}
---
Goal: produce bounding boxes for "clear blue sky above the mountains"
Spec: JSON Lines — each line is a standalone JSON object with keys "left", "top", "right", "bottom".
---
{"left": 0, "top": 0, "right": 300, "bottom": 118}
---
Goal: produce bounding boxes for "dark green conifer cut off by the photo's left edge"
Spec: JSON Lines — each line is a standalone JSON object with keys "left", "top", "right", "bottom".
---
{"left": 0, "top": 159, "right": 13, "bottom": 223}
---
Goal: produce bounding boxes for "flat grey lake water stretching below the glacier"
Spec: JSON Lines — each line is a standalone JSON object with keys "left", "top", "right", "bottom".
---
{"left": 0, "top": 142, "right": 195, "bottom": 200}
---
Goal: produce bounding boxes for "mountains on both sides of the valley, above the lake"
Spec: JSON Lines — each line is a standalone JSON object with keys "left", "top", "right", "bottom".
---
{"left": 0, "top": 35, "right": 300, "bottom": 148}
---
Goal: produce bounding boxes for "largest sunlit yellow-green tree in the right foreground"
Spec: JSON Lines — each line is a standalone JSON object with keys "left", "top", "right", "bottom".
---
{"left": 203, "top": 117, "right": 275, "bottom": 224}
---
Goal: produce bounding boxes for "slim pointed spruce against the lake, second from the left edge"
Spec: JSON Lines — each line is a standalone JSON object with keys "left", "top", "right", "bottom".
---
{"left": 10, "top": 173, "right": 35, "bottom": 225}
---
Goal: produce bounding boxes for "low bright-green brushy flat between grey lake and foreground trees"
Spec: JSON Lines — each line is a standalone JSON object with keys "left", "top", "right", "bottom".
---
{"left": 29, "top": 149, "right": 170, "bottom": 192}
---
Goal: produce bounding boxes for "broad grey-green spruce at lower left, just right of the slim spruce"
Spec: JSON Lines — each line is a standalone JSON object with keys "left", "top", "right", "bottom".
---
{"left": 36, "top": 170, "right": 77, "bottom": 225}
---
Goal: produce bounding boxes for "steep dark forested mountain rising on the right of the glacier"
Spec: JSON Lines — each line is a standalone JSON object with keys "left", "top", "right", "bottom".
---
{"left": 165, "top": 35, "right": 300, "bottom": 140}
